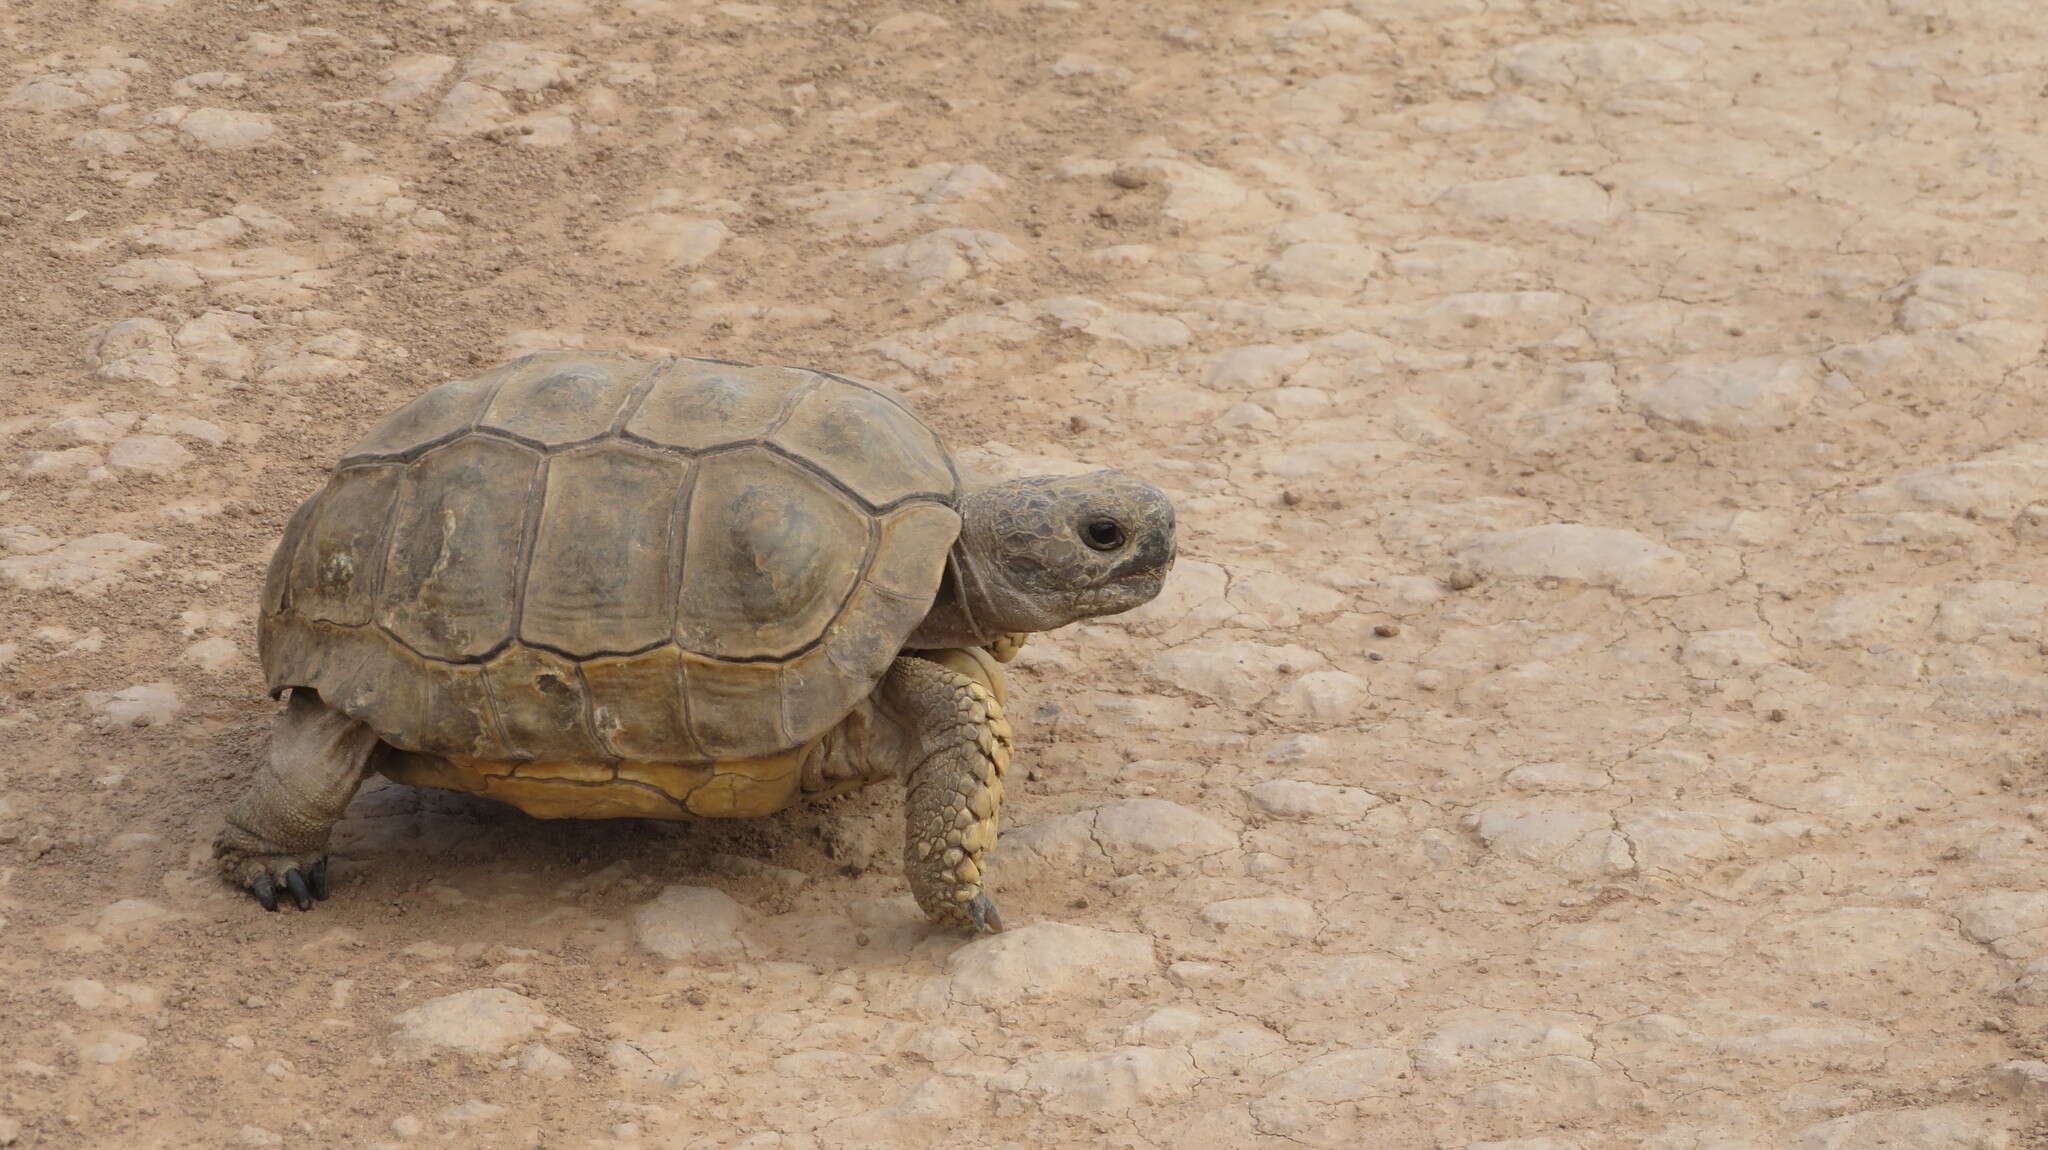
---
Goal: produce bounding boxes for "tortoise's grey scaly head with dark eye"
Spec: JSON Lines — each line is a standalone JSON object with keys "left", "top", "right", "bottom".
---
{"left": 954, "top": 471, "right": 1174, "bottom": 632}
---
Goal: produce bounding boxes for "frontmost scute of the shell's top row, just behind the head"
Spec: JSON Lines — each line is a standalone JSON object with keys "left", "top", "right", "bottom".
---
{"left": 770, "top": 379, "right": 954, "bottom": 507}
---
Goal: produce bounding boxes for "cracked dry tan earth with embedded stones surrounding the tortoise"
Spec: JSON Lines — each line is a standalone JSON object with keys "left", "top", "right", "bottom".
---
{"left": 0, "top": 0, "right": 2048, "bottom": 1150}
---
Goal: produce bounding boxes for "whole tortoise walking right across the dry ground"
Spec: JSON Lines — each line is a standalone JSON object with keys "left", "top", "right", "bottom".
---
{"left": 215, "top": 352, "right": 1176, "bottom": 931}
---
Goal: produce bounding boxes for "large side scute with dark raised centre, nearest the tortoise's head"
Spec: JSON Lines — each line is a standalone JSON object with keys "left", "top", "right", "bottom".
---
{"left": 676, "top": 448, "right": 868, "bottom": 659}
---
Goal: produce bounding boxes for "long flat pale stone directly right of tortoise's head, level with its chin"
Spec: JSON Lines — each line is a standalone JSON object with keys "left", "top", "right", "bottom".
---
{"left": 1454, "top": 524, "right": 1696, "bottom": 595}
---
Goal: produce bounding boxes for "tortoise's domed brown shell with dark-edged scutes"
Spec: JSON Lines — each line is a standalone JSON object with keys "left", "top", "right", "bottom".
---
{"left": 260, "top": 352, "right": 961, "bottom": 763}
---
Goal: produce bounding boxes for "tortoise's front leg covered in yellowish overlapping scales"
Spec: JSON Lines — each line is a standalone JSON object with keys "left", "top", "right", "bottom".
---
{"left": 883, "top": 651, "right": 1010, "bottom": 933}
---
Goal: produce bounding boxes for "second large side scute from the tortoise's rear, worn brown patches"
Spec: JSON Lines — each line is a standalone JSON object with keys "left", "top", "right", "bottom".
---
{"left": 377, "top": 436, "right": 543, "bottom": 659}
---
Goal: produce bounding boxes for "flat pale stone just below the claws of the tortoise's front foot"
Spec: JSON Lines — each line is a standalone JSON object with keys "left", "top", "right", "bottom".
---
{"left": 946, "top": 921, "right": 1157, "bottom": 1007}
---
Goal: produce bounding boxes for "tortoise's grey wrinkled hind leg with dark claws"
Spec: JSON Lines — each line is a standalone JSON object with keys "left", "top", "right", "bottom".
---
{"left": 213, "top": 688, "right": 379, "bottom": 911}
